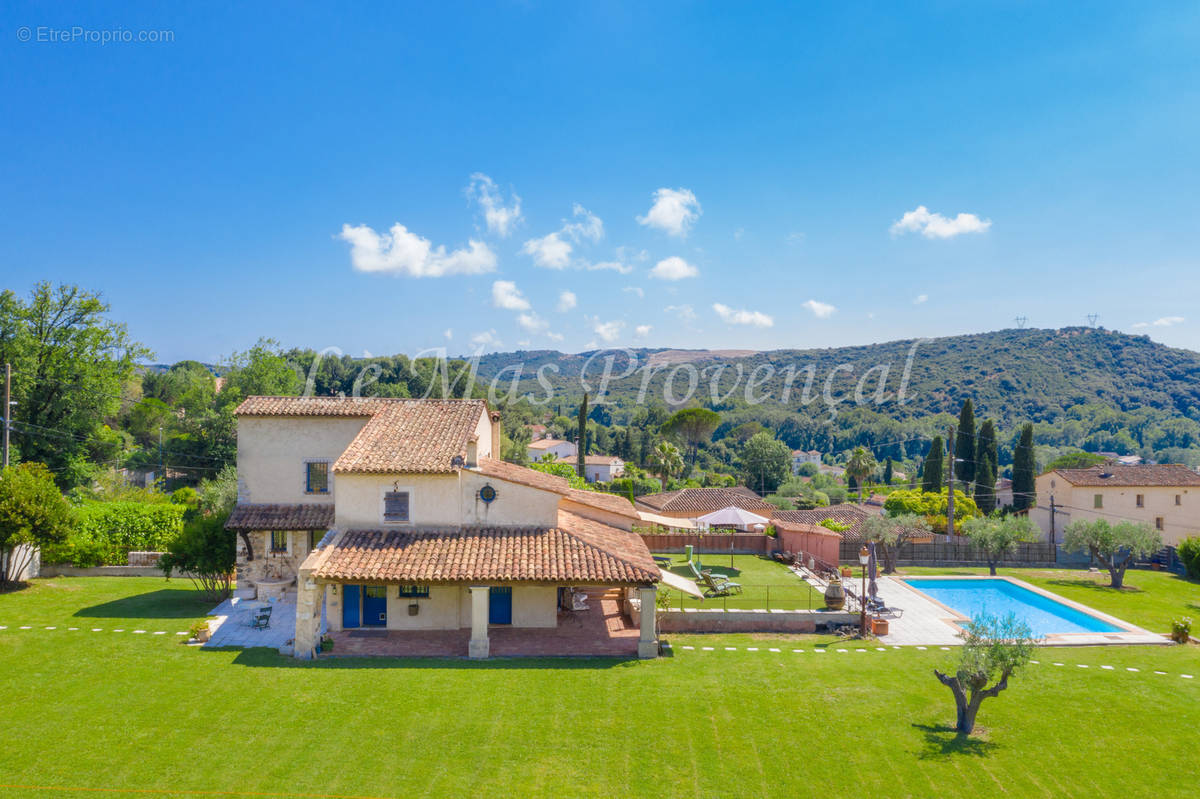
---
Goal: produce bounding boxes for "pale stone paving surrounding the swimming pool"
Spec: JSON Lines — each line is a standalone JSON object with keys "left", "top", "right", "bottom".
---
{"left": 876, "top": 576, "right": 1170, "bottom": 647}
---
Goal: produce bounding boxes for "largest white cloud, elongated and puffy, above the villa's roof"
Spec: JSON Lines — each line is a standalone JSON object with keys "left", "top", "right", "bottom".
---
{"left": 337, "top": 222, "right": 496, "bottom": 277}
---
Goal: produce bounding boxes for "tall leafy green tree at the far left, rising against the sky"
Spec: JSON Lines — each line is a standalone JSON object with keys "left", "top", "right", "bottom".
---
{"left": 0, "top": 283, "right": 151, "bottom": 488}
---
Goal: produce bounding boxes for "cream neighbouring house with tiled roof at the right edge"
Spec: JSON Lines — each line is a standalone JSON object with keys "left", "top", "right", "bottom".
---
{"left": 1030, "top": 463, "right": 1200, "bottom": 546}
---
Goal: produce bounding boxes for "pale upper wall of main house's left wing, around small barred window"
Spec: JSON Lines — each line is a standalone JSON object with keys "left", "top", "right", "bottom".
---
{"left": 238, "top": 416, "right": 367, "bottom": 503}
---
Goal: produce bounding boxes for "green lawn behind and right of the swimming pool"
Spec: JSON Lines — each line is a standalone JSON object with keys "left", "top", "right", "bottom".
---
{"left": 900, "top": 567, "right": 1200, "bottom": 635}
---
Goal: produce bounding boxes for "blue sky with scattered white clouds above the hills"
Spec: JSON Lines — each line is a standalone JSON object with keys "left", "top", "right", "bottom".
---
{"left": 0, "top": 2, "right": 1200, "bottom": 361}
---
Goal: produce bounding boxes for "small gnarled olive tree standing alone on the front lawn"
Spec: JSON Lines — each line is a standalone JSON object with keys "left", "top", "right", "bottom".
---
{"left": 934, "top": 613, "right": 1038, "bottom": 735}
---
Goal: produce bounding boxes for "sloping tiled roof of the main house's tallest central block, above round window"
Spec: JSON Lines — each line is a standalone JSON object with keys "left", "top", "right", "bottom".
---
{"left": 334, "top": 400, "right": 487, "bottom": 474}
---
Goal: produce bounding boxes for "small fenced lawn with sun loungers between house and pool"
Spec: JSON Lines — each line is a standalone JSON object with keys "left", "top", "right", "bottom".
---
{"left": 665, "top": 554, "right": 824, "bottom": 609}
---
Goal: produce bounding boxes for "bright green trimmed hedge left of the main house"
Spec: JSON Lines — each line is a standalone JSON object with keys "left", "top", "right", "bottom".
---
{"left": 42, "top": 501, "right": 186, "bottom": 567}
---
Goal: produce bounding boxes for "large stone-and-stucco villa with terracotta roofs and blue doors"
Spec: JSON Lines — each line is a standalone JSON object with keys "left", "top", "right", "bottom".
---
{"left": 226, "top": 397, "right": 660, "bottom": 657}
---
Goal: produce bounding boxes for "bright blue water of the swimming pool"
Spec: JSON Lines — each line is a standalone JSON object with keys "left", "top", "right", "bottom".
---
{"left": 905, "top": 577, "right": 1122, "bottom": 637}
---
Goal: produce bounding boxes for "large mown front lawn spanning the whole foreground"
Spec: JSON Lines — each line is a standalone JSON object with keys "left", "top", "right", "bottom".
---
{"left": 0, "top": 578, "right": 1200, "bottom": 799}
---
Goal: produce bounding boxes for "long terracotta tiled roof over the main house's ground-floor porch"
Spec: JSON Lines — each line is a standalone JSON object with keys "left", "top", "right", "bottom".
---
{"left": 313, "top": 512, "right": 660, "bottom": 585}
